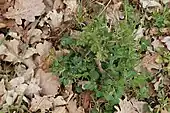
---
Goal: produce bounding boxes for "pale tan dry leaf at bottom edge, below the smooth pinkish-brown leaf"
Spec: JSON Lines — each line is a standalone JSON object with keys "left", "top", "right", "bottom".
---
{"left": 30, "top": 95, "right": 52, "bottom": 113}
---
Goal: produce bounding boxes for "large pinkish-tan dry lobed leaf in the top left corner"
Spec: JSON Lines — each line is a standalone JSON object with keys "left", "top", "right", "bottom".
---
{"left": 4, "top": 0, "right": 45, "bottom": 25}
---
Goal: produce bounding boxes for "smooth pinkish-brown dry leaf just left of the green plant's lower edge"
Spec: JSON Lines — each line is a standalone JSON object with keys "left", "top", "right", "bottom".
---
{"left": 36, "top": 69, "right": 60, "bottom": 95}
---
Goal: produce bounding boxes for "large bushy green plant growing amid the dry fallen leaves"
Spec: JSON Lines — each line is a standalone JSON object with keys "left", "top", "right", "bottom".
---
{"left": 52, "top": 3, "right": 147, "bottom": 113}
